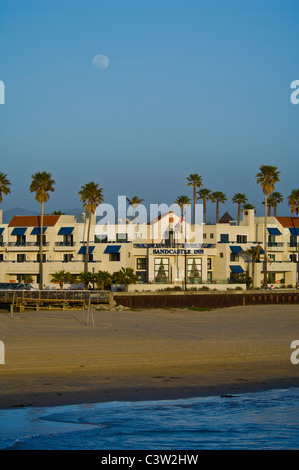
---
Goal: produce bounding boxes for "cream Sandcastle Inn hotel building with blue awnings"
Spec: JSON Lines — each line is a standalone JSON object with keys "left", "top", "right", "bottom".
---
{"left": 0, "top": 210, "right": 299, "bottom": 291}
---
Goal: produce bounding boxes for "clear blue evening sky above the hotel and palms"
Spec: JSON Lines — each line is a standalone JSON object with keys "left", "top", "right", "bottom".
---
{"left": 0, "top": 0, "right": 299, "bottom": 220}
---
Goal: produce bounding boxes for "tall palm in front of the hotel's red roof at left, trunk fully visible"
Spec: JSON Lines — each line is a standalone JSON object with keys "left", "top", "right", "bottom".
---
{"left": 29, "top": 171, "right": 55, "bottom": 290}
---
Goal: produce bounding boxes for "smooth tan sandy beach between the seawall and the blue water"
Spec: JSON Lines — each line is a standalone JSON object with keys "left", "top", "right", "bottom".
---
{"left": 0, "top": 305, "right": 299, "bottom": 409}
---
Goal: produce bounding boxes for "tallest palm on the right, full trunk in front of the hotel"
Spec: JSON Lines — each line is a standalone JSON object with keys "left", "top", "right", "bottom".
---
{"left": 256, "top": 165, "right": 280, "bottom": 288}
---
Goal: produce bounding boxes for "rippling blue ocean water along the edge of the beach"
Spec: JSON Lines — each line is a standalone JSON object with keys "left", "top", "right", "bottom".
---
{"left": 0, "top": 388, "right": 299, "bottom": 450}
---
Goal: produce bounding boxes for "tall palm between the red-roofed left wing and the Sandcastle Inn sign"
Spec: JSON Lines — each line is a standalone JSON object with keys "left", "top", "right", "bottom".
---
{"left": 79, "top": 181, "right": 104, "bottom": 273}
